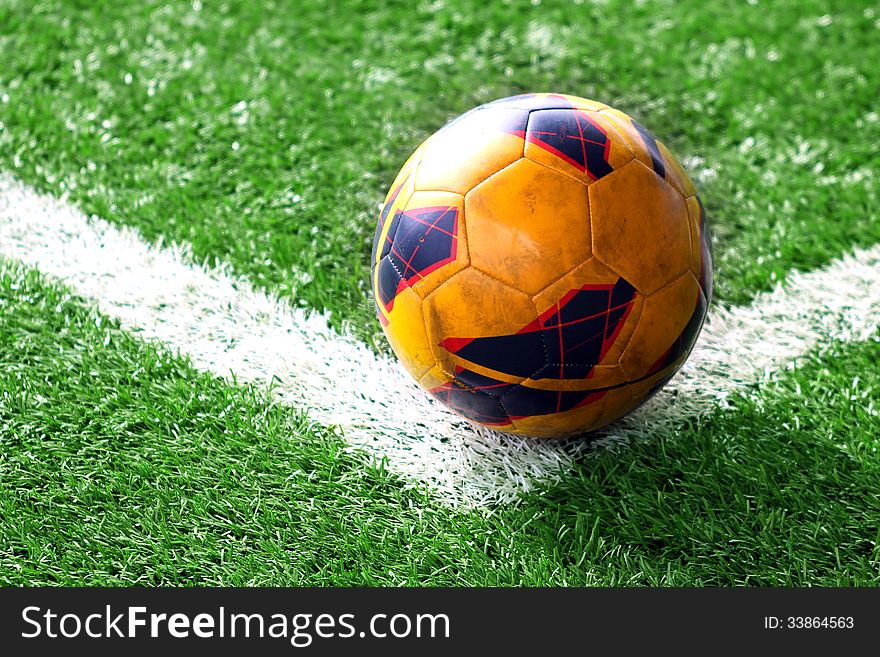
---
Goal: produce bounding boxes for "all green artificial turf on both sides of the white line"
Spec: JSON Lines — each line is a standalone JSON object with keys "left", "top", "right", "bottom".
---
{"left": 0, "top": 0, "right": 880, "bottom": 585}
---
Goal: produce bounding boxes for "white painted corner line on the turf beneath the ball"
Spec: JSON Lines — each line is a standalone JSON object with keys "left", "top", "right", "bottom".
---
{"left": 0, "top": 174, "right": 880, "bottom": 507}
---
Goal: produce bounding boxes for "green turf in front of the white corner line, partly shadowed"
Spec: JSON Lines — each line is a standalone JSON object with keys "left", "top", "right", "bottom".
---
{"left": 0, "top": 261, "right": 880, "bottom": 586}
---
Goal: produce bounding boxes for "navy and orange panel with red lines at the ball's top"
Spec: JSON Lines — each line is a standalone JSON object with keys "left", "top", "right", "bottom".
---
{"left": 525, "top": 109, "right": 633, "bottom": 184}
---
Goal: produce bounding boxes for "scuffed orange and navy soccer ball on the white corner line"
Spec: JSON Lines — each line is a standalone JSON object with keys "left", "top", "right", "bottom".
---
{"left": 371, "top": 94, "right": 712, "bottom": 437}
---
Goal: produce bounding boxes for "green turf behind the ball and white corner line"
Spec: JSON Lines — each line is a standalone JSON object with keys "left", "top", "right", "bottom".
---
{"left": 0, "top": 0, "right": 880, "bottom": 341}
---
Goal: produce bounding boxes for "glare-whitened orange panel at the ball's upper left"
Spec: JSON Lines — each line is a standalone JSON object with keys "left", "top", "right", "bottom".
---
{"left": 416, "top": 107, "right": 528, "bottom": 194}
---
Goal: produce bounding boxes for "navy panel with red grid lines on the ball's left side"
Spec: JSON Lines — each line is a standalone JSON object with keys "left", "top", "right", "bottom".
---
{"left": 373, "top": 192, "right": 468, "bottom": 322}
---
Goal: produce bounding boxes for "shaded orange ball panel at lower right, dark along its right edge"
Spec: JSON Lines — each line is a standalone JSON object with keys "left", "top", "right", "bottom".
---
{"left": 620, "top": 271, "right": 706, "bottom": 381}
